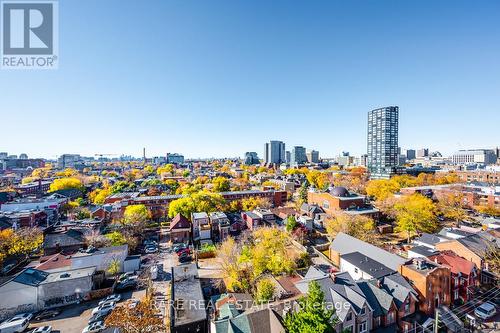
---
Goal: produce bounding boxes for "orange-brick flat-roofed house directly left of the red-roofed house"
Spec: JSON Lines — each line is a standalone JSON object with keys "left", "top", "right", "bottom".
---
{"left": 399, "top": 258, "right": 451, "bottom": 315}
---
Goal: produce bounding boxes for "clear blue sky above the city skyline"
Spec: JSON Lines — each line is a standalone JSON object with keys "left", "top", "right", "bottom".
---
{"left": 0, "top": 0, "right": 500, "bottom": 158}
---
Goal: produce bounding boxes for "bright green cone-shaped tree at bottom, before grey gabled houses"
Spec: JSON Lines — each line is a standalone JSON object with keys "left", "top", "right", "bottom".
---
{"left": 284, "top": 281, "right": 337, "bottom": 333}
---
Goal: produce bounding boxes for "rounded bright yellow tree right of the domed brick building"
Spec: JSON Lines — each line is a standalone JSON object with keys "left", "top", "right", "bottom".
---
{"left": 394, "top": 193, "right": 437, "bottom": 243}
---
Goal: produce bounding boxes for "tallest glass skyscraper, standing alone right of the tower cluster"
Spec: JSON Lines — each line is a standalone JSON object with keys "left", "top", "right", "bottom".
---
{"left": 367, "top": 106, "right": 399, "bottom": 179}
